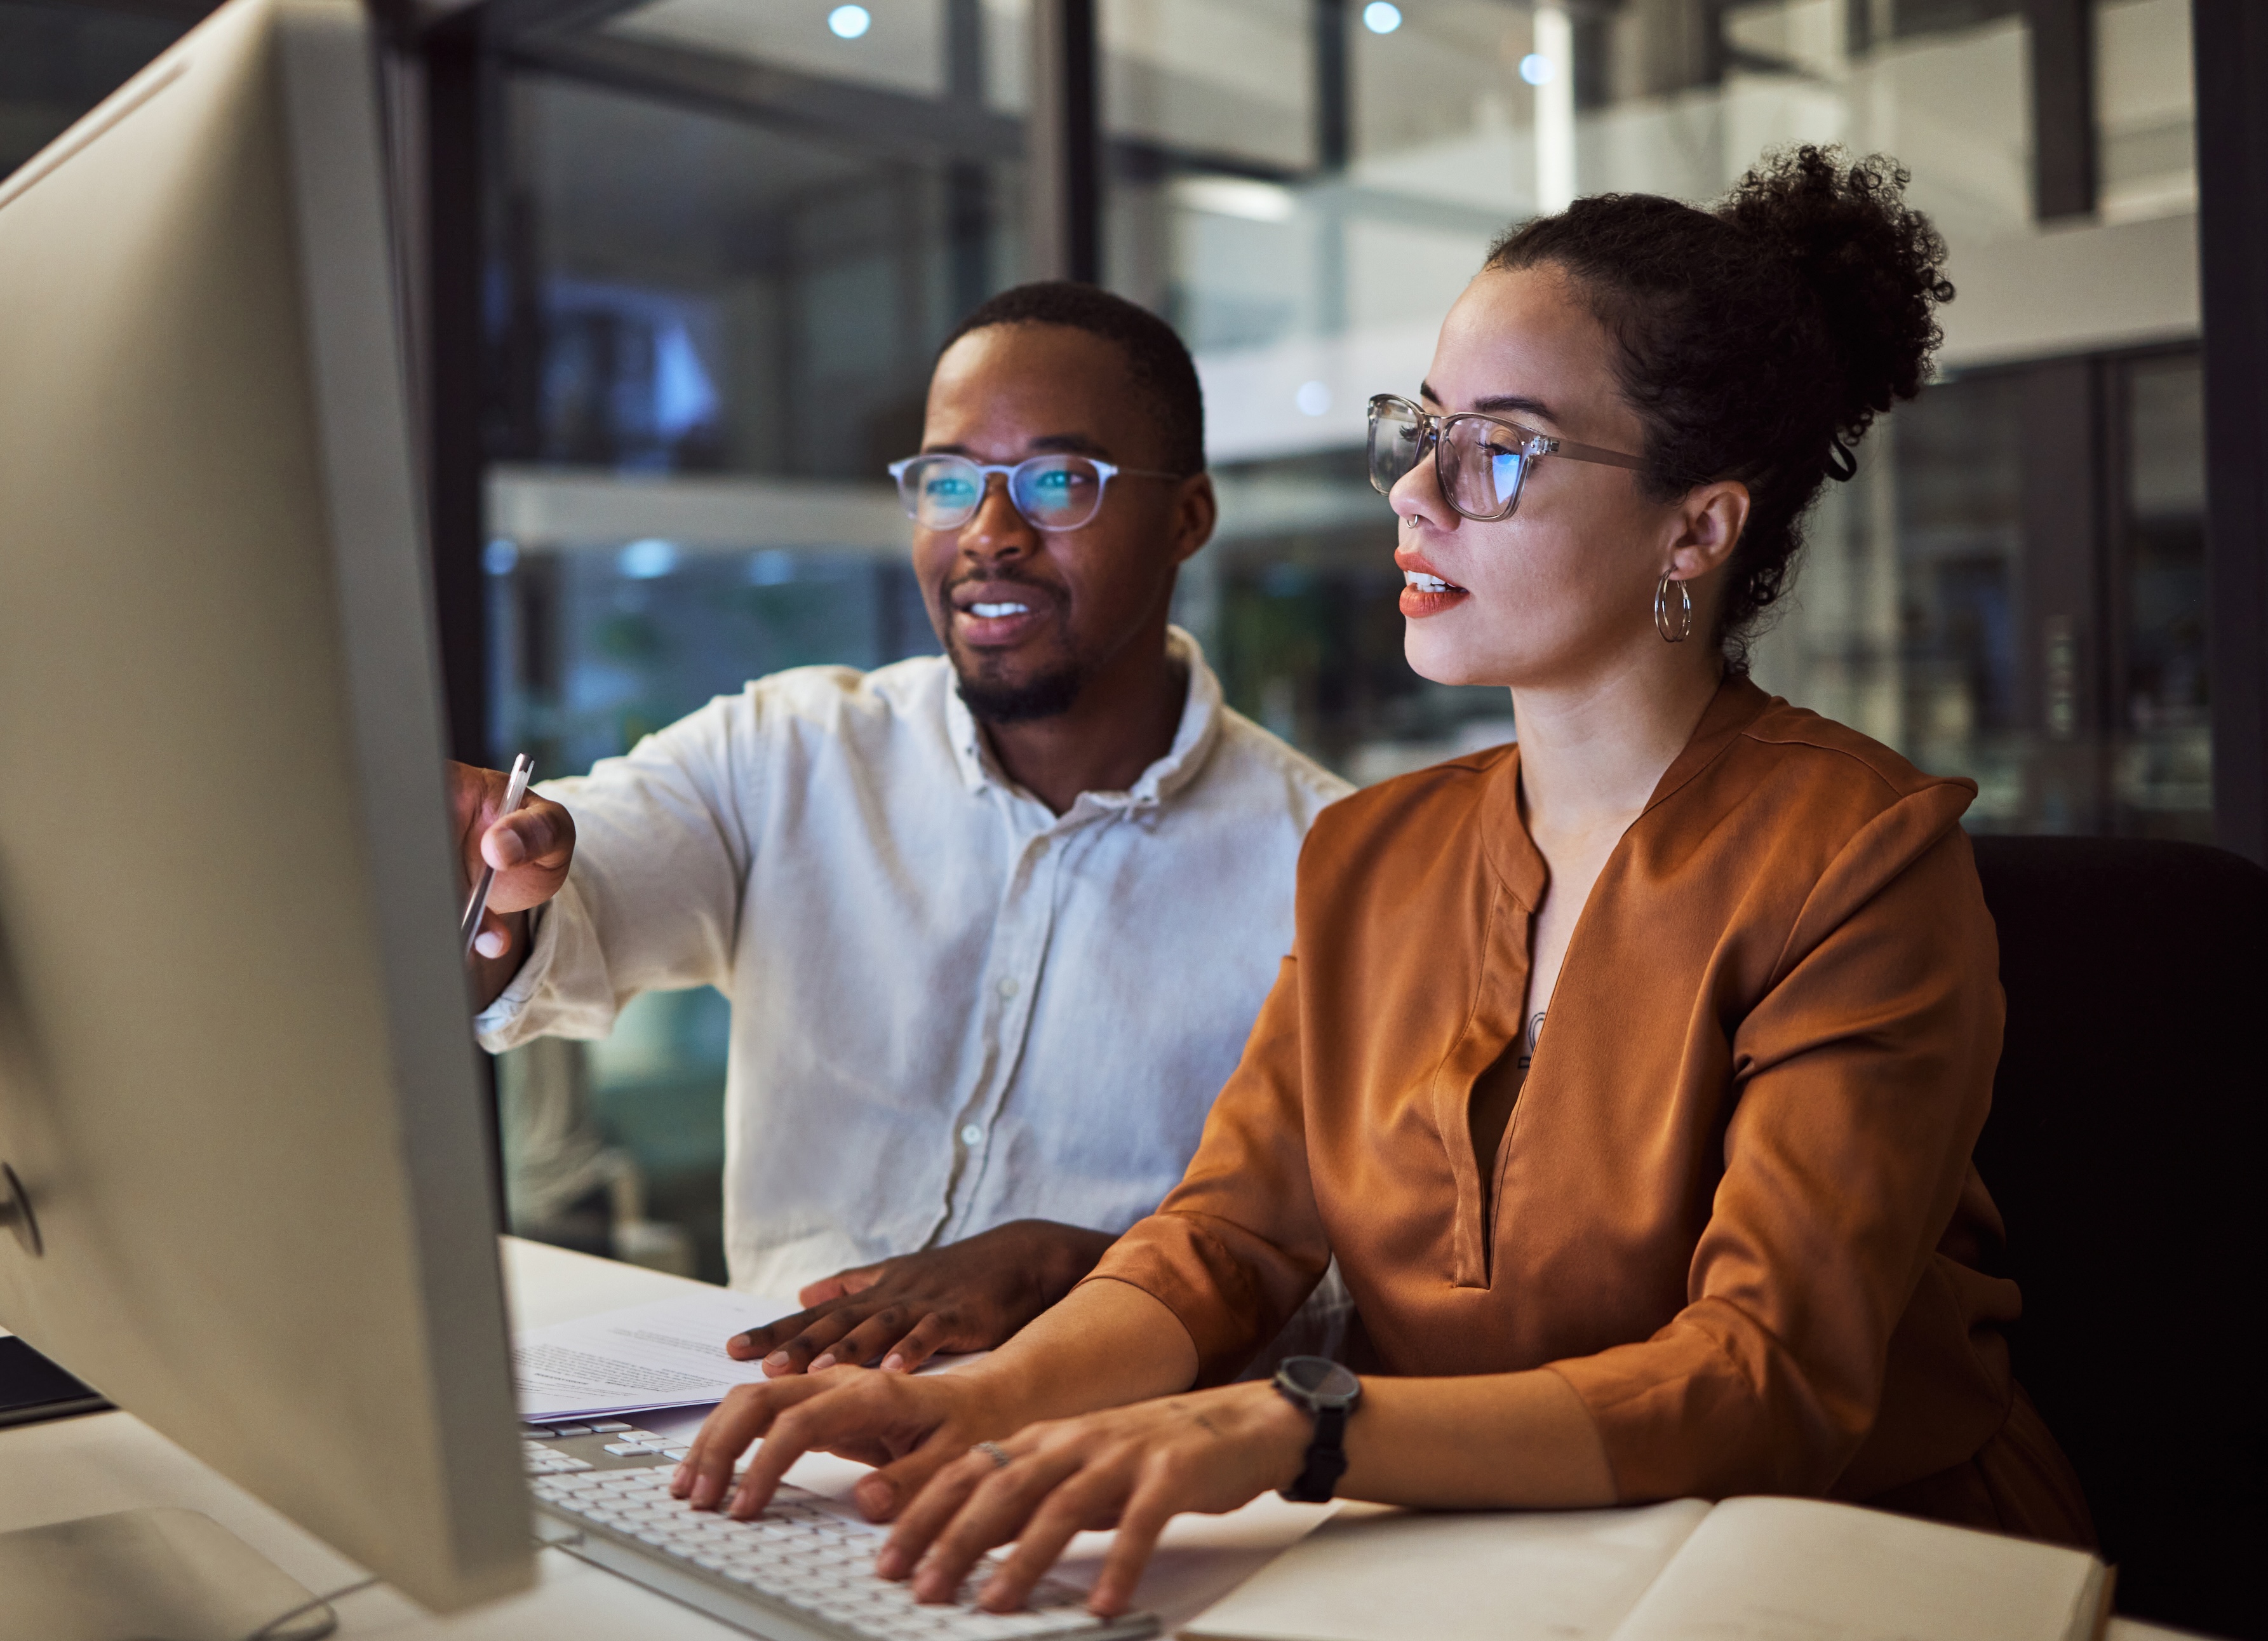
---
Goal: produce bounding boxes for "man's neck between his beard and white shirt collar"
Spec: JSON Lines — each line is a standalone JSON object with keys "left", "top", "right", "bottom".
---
{"left": 982, "top": 629, "right": 1188, "bottom": 815}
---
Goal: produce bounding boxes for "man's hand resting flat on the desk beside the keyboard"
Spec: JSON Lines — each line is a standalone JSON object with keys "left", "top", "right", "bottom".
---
{"left": 726, "top": 1219, "right": 1116, "bottom": 1378}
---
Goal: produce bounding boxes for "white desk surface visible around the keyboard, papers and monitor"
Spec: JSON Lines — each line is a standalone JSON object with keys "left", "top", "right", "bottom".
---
{"left": 0, "top": 1237, "right": 2204, "bottom": 1641}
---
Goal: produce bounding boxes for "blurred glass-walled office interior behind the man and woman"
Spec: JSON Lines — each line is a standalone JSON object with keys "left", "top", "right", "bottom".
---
{"left": 0, "top": 0, "right": 2268, "bottom": 1280}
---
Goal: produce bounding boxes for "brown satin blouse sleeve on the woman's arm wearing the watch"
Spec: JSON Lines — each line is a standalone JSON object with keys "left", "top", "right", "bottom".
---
{"left": 1552, "top": 792, "right": 2003, "bottom": 1503}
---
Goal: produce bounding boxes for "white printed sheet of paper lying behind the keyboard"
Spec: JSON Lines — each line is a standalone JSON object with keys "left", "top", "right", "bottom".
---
{"left": 513, "top": 1287, "right": 801, "bottom": 1419}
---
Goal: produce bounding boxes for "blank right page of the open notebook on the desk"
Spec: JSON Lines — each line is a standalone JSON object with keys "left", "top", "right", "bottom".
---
{"left": 1620, "top": 1498, "right": 2100, "bottom": 1641}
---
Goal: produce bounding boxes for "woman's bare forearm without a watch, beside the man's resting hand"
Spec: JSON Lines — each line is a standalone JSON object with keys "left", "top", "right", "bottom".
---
{"left": 964, "top": 1280, "right": 1197, "bottom": 1428}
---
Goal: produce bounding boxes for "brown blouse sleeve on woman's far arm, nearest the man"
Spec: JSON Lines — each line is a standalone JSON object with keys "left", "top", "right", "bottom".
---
{"left": 1087, "top": 958, "right": 1331, "bottom": 1384}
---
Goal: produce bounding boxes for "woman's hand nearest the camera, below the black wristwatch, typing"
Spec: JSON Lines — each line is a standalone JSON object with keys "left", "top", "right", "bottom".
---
{"left": 875, "top": 1380, "right": 1313, "bottom": 1616}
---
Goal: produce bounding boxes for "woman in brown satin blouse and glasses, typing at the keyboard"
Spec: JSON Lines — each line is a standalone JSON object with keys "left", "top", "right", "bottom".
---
{"left": 678, "top": 147, "right": 2089, "bottom": 1614}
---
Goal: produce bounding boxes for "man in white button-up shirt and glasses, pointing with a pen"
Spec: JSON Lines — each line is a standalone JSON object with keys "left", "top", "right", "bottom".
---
{"left": 456, "top": 284, "right": 1347, "bottom": 1373}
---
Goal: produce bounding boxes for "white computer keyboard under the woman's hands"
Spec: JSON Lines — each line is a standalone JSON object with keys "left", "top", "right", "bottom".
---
{"left": 526, "top": 1423, "right": 1157, "bottom": 1641}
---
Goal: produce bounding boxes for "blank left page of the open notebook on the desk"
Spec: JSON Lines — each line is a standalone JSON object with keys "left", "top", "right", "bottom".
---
{"left": 1181, "top": 1498, "right": 1708, "bottom": 1641}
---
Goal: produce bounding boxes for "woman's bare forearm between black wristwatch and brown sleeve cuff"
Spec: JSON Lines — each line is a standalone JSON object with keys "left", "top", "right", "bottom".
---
{"left": 1338, "top": 1368, "right": 1615, "bottom": 1509}
